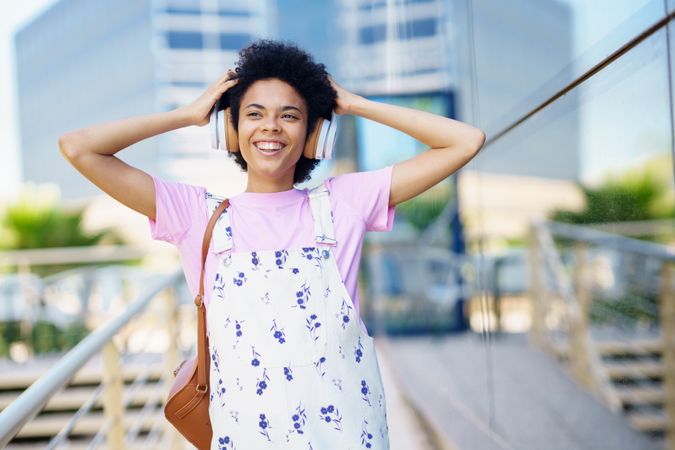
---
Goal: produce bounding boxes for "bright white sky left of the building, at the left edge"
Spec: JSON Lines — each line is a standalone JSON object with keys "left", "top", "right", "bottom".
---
{"left": 0, "top": 0, "right": 56, "bottom": 199}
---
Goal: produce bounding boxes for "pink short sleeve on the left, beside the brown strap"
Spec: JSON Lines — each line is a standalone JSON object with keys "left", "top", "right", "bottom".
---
{"left": 148, "top": 176, "right": 206, "bottom": 245}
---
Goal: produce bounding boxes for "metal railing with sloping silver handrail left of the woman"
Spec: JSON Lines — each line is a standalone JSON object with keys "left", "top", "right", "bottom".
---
{"left": 0, "top": 244, "right": 187, "bottom": 449}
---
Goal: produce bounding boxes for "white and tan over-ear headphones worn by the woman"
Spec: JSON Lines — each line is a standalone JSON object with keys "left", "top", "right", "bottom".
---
{"left": 209, "top": 92, "right": 337, "bottom": 159}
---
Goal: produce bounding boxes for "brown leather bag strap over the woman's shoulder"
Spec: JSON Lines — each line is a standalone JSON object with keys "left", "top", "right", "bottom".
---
{"left": 195, "top": 199, "right": 230, "bottom": 393}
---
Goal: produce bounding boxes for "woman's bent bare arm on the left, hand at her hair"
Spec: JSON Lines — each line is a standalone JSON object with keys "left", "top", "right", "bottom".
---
{"left": 59, "top": 71, "right": 236, "bottom": 220}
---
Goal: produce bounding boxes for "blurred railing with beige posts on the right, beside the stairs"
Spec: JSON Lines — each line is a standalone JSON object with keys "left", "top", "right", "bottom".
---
{"left": 529, "top": 221, "right": 675, "bottom": 449}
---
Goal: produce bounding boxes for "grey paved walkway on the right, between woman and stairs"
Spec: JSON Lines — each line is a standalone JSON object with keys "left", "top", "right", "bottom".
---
{"left": 376, "top": 333, "right": 662, "bottom": 450}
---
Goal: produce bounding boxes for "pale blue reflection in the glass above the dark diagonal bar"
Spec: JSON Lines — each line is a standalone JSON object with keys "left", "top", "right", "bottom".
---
{"left": 472, "top": 0, "right": 672, "bottom": 134}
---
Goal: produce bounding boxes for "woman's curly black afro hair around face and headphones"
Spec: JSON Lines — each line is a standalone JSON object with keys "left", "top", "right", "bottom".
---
{"left": 223, "top": 39, "right": 337, "bottom": 184}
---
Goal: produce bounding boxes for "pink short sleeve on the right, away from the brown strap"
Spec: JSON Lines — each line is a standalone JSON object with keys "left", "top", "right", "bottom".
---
{"left": 328, "top": 166, "right": 395, "bottom": 231}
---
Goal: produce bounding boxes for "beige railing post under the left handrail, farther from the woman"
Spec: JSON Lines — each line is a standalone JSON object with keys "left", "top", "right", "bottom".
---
{"left": 102, "top": 340, "right": 124, "bottom": 449}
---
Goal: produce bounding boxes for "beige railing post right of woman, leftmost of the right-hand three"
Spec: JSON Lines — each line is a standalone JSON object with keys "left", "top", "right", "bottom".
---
{"left": 528, "top": 225, "right": 549, "bottom": 350}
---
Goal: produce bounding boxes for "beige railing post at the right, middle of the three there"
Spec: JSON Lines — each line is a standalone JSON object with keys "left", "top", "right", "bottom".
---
{"left": 569, "top": 242, "right": 597, "bottom": 390}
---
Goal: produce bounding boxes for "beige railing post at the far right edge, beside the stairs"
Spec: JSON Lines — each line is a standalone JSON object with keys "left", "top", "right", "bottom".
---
{"left": 659, "top": 261, "right": 675, "bottom": 450}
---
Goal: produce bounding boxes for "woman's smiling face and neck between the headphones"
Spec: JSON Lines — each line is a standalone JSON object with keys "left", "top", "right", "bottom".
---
{"left": 238, "top": 78, "right": 307, "bottom": 192}
